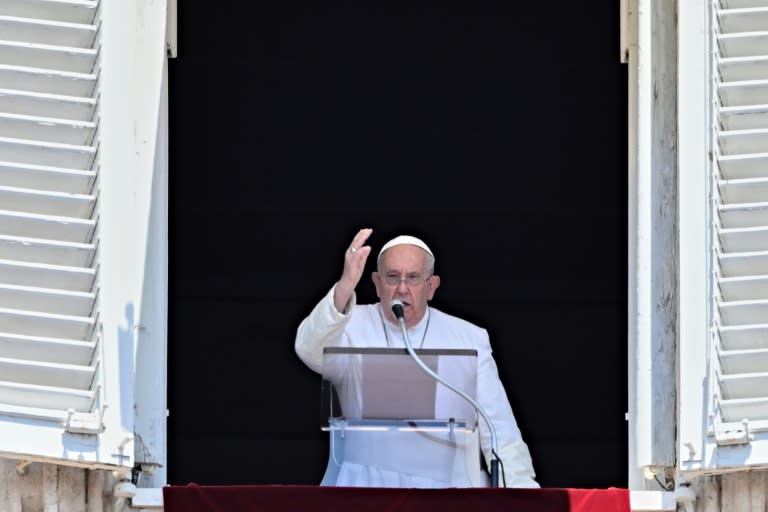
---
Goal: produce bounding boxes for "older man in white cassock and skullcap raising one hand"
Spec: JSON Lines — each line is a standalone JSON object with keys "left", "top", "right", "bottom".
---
{"left": 295, "top": 228, "right": 539, "bottom": 488}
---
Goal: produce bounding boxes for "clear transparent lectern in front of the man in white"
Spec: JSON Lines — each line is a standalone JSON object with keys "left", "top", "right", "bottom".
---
{"left": 321, "top": 347, "right": 489, "bottom": 487}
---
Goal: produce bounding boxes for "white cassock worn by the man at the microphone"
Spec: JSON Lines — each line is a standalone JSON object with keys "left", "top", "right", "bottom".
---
{"left": 295, "top": 288, "right": 539, "bottom": 488}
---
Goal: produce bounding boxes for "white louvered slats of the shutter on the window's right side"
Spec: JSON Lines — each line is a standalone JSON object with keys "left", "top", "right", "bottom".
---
{"left": 705, "top": 0, "right": 768, "bottom": 469}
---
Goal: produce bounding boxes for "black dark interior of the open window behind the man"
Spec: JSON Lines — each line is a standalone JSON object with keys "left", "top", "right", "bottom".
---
{"left": 168, "top": 0, "right": 628, "bottom": 487}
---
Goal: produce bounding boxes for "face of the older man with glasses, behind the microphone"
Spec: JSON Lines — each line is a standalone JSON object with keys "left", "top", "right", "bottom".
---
{"left": 371, "top": 245, "right": 440, "bottom": 327}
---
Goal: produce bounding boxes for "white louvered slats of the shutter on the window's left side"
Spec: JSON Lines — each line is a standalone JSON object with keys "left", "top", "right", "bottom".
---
{"left": 0, "top": 0, "right": 115, "bottom": 462}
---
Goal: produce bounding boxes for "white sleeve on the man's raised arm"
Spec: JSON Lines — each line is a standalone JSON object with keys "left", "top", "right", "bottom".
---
{"left": 294, "top": 285, "right": 357, "bottom": 373}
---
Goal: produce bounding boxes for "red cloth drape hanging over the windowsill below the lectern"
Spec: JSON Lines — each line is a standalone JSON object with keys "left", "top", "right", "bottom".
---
{"left": 163, "top": 484, "right": 630, "bottom": 512}
